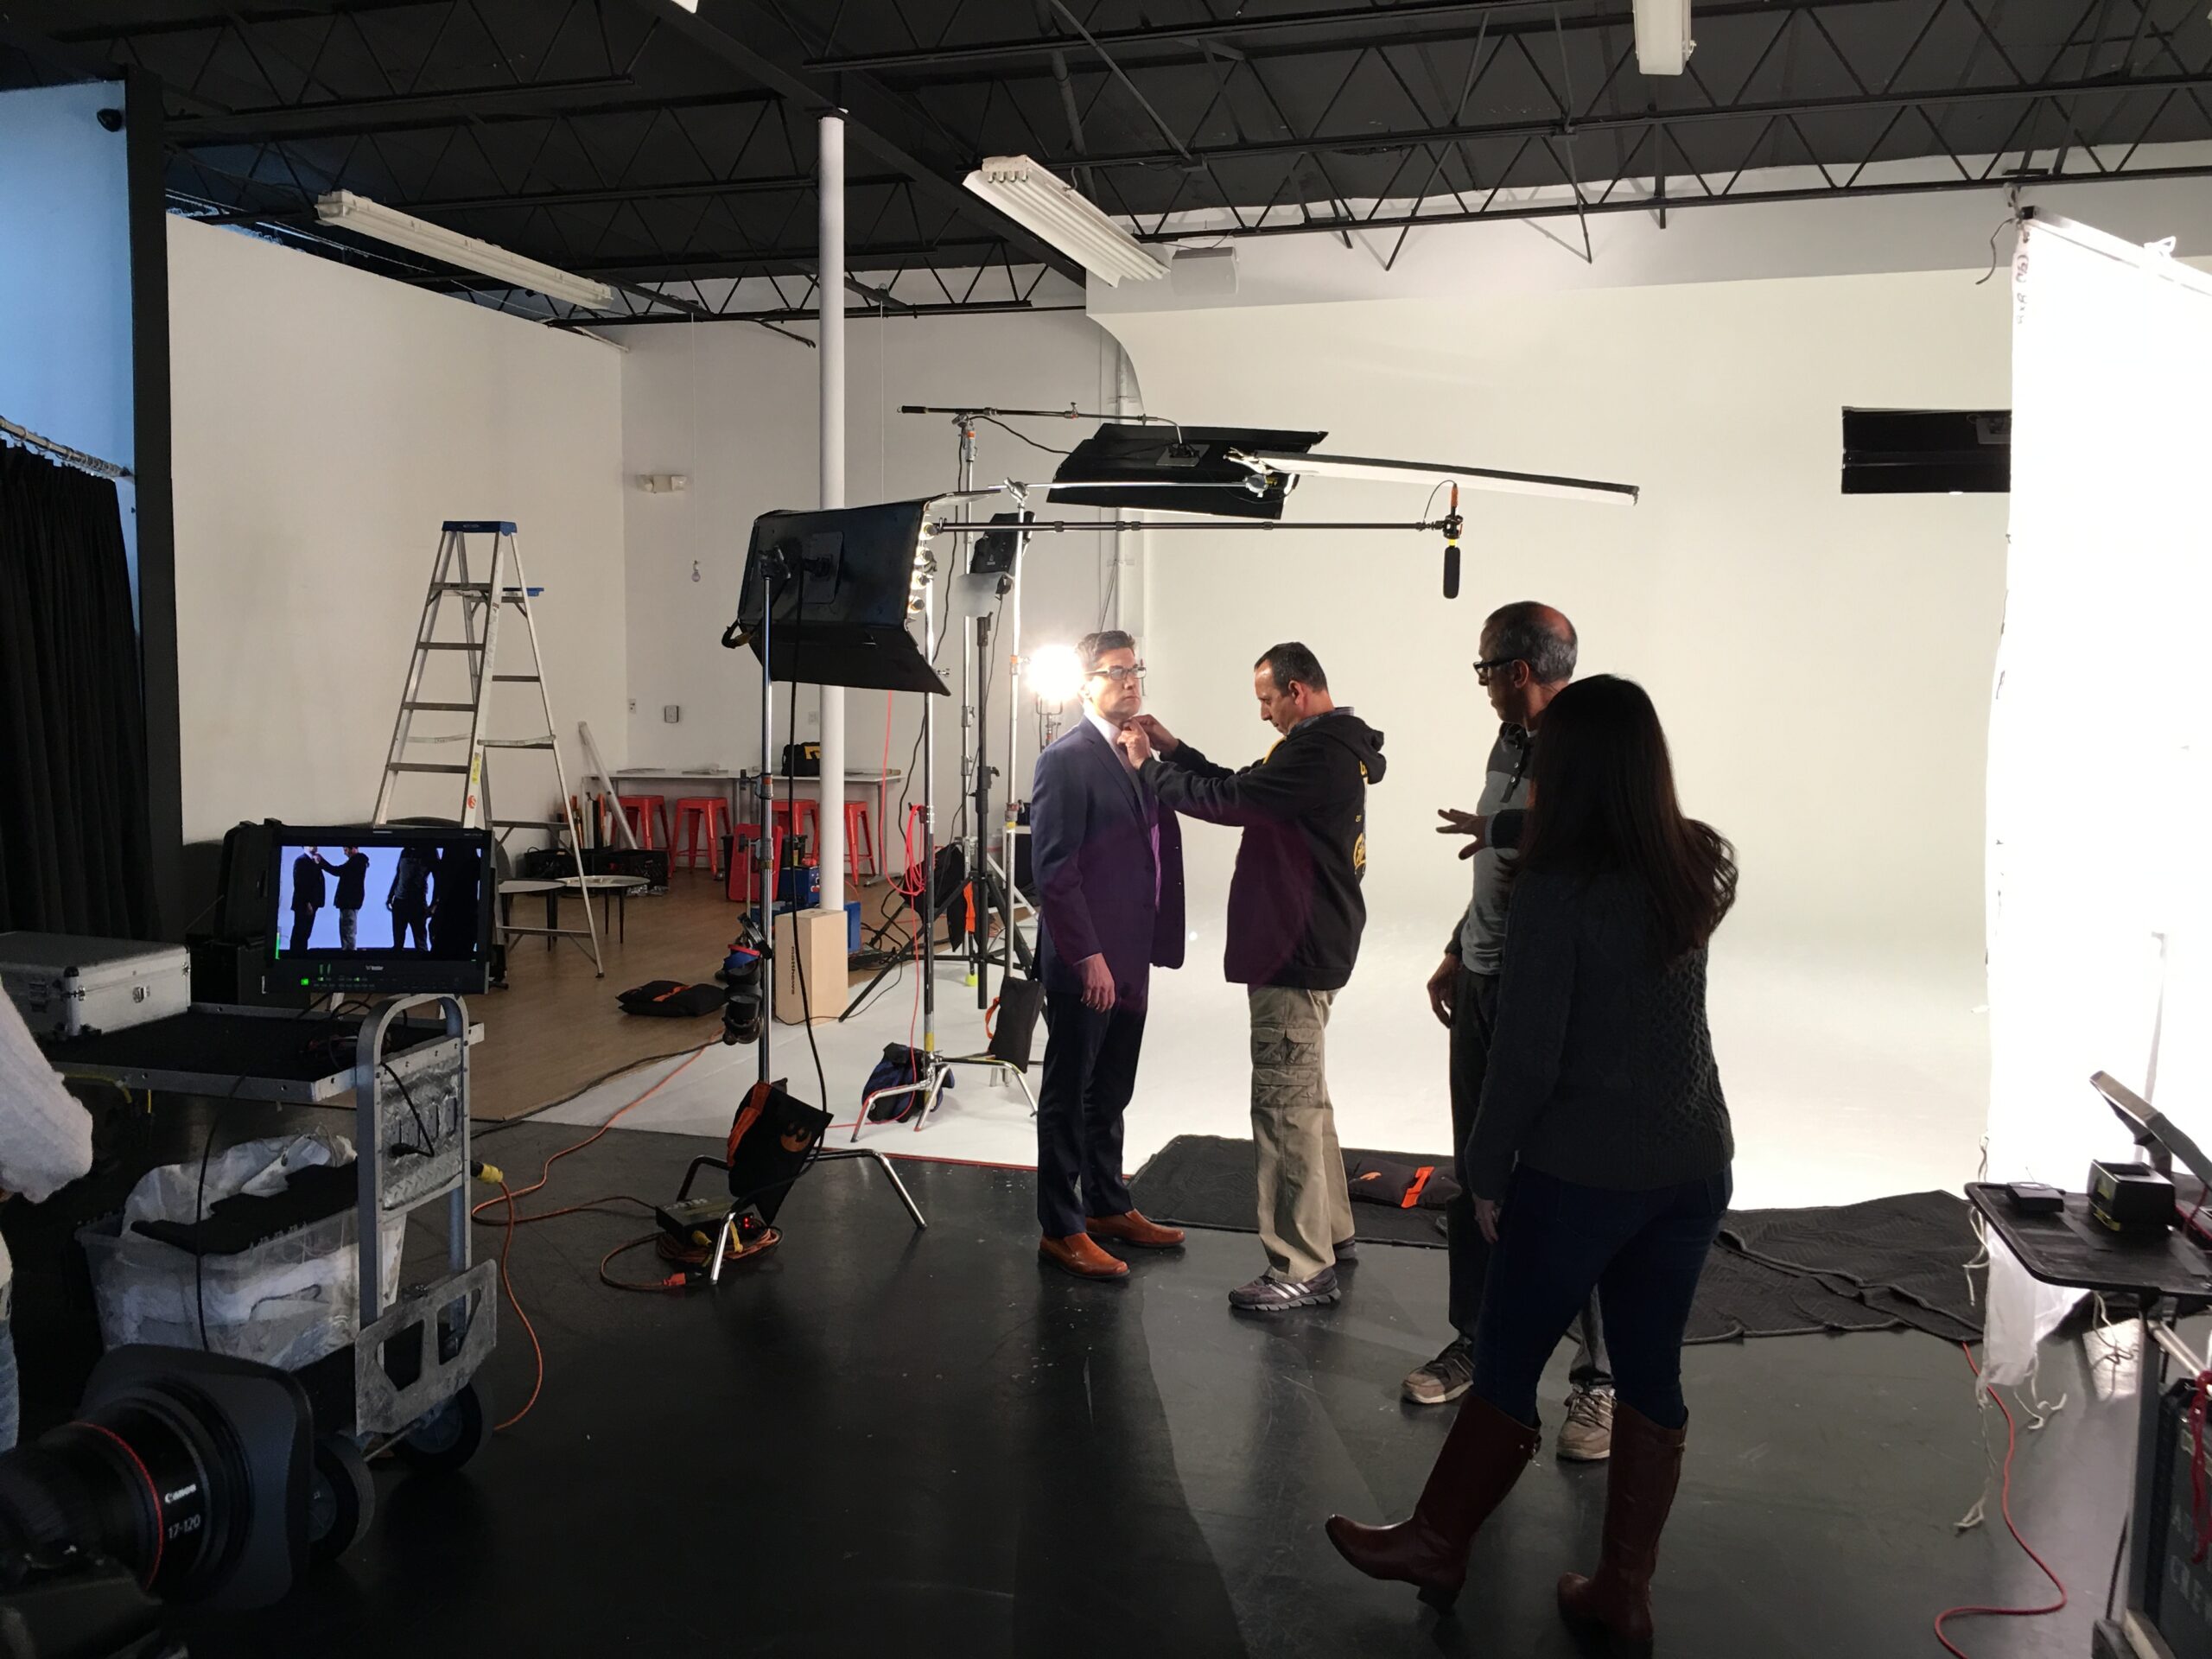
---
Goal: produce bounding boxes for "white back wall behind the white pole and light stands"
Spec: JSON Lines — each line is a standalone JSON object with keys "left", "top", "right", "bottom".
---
{"left": 617, "top": 312, "right": 1115, "bottom": 865}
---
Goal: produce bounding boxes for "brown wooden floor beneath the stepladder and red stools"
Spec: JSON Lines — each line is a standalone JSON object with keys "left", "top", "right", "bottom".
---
{"left": 469, "top": 869, "right": 1008, "bottom": 1119}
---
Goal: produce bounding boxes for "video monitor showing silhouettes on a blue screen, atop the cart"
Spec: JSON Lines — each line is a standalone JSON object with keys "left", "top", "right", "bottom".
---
{"left": 264, "top": 825, "right": 493, "bottom": 995}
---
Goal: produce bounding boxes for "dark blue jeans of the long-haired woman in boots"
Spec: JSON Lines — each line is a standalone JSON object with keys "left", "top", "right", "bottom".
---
{"left": 1473, "top": 1168, "right": 1734, "bottom": 1429}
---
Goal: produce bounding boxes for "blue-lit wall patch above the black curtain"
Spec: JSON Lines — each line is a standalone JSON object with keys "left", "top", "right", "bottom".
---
{"left": 0, "top": 82, "right": 137, "bottom": 564}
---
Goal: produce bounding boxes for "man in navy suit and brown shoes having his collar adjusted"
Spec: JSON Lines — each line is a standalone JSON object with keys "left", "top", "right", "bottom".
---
{"left": 1028, "top": 628, "right": 1184, "bottom": 1279}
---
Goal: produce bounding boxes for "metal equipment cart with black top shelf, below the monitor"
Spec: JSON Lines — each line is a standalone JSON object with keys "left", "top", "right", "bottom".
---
{"left": 47, "top": 995, "right": 498, "bottom": 1560}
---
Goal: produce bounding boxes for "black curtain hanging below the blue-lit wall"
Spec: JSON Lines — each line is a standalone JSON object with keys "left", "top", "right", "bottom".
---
{"left": 0, "top": 445, "right": 159, "bottom": 938}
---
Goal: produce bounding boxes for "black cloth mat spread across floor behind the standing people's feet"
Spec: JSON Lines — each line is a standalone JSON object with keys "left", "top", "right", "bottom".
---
{"left": 1130, "top": 1135, "right": 1984, "bottom": 1343}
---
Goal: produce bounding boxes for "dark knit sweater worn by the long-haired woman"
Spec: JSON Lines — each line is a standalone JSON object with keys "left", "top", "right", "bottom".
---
{"left": 1466, "top": 874, "right": 1737, "bottom": 1199}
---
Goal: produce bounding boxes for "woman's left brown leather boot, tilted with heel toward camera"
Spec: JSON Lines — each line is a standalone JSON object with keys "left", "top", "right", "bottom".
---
{"left": 1327, "top": 1394, "right": 1544, "bottom": 1612}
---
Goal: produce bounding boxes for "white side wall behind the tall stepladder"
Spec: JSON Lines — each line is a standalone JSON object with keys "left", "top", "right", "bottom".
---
{"left": 168, "top": 217, "right": 626, "bottom": 841}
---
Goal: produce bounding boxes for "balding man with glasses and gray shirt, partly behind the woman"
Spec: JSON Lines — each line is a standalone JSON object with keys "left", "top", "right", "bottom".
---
{"left": 1402, "top": 601, "right": 1612, "bottom": 1462}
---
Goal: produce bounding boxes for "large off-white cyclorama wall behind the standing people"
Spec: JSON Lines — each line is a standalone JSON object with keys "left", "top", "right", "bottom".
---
{"left": 1106, "top": 267, "right": 2008, "bottom": 964}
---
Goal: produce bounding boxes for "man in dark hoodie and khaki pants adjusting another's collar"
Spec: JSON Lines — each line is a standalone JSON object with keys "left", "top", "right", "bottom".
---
{"left": 1119, "top": 644, "right": 1382, "bottom": 1314}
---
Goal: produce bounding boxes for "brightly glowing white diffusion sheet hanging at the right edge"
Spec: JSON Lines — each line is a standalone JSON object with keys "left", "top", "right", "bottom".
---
{"left": 1984, "top": 221, "right": 2212, "bottom": 1382}
